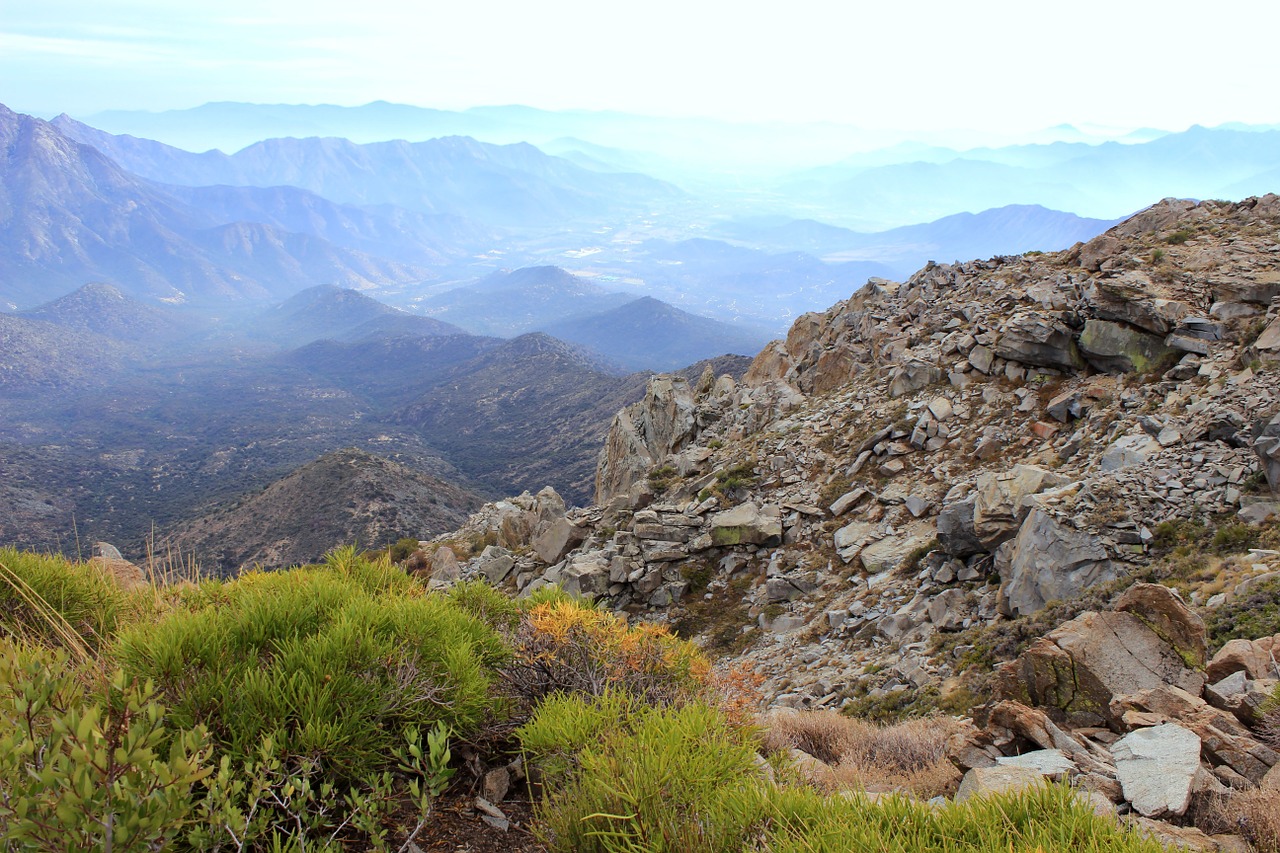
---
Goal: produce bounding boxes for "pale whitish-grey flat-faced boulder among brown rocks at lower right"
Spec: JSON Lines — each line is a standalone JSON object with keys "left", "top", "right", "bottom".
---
{"left": 1111, "top": 722, "right": 1201, "bottom": 817}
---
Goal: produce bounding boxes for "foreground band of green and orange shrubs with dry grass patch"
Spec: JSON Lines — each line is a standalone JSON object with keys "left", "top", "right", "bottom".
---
{"left": 0, "top": 547, "right": 1172, "bottom": 853}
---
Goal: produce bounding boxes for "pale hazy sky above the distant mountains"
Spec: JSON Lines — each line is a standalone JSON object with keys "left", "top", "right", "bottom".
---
{"left": 0, "top": 0, "right": 1280, "bottom": 129}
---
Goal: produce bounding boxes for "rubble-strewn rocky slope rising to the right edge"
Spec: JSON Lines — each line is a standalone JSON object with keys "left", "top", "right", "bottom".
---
{"left": 419, "top": 196, "right": 1280, "bottom": 847}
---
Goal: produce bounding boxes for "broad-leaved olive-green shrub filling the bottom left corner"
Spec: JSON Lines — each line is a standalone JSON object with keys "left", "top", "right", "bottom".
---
{"left": 0, "top": 640, "right": 214, "bottom": 853}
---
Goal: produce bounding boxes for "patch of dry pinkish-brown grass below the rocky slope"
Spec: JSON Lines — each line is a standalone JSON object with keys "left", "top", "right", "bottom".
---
{"left": 764, "top": 711, "right": 960, "bottom": 798}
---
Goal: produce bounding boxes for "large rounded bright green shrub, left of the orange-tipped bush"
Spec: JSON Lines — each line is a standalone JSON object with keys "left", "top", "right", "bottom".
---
{"left": 119, "top": 549, "right": 507, "bottom": 781}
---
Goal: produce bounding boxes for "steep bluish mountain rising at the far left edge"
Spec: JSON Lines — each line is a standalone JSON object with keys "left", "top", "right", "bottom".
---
{"left": 0, "top": 106, "right": 429, "bottom": 307}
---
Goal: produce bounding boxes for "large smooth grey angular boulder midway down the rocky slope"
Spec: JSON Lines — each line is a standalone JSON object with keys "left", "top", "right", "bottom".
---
{"left": 996, "top": 508, "right": 1119, "bottom": 616}
